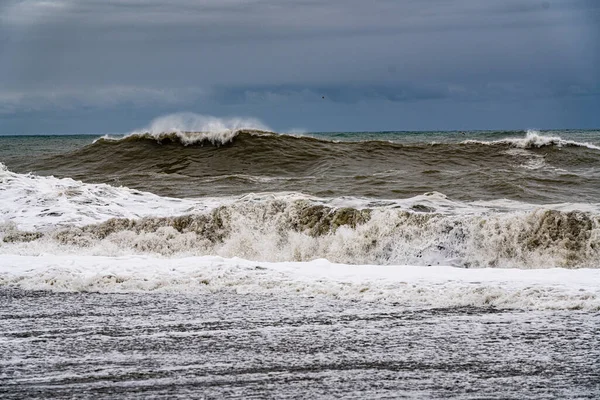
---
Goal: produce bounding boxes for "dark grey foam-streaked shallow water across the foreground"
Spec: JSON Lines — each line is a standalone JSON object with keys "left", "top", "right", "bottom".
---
{"left": 0, "top": 288, "right": 600, "bottom": 399}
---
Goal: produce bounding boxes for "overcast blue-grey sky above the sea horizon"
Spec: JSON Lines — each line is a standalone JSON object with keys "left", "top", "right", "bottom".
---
{"left": 0, "top": 0, "right": 600, "bottom": 134}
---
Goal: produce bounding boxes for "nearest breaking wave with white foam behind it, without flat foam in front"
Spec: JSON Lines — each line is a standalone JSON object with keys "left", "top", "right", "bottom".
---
{"left": 0, "top": 162, "right": 600, "bottom": 268}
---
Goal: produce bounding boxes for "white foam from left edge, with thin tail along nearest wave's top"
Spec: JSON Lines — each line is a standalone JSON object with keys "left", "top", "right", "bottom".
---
{"left": 0, "top": 163, "right": 488, "bottom": 230}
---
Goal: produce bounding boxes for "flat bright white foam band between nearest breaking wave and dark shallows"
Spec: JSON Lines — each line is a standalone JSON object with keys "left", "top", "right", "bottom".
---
{"left": 0, "top": 255, "right": 600, "bottom": 311}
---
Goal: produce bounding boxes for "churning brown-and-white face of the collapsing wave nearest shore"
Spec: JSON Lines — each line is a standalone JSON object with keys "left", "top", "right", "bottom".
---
{"left": 0, "top": 199, "right": 600, "bottom": 268}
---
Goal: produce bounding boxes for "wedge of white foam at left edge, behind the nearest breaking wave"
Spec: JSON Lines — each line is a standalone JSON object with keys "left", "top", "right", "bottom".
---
{"left": 0, "top": 163, "right": 226, "bottom": 230}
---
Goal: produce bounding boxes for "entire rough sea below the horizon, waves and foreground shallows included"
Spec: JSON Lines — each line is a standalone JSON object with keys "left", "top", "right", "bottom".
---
{"left": 0, "top": 118, "right": 600, "bottom": 398}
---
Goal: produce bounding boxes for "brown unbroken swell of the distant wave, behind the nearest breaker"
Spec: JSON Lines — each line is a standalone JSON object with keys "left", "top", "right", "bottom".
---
{"left": 2, "top": 130, "right": 600, "bottom": 203}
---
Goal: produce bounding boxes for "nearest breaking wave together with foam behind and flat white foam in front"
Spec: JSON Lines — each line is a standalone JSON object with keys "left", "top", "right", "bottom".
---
{"left": 0, "top": 158, "right": 600, "bottom": 311}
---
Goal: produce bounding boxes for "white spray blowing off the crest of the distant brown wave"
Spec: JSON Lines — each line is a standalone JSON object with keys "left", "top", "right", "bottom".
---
{"left": 97, "top": 113, "right": 270, "bottom": 145}
